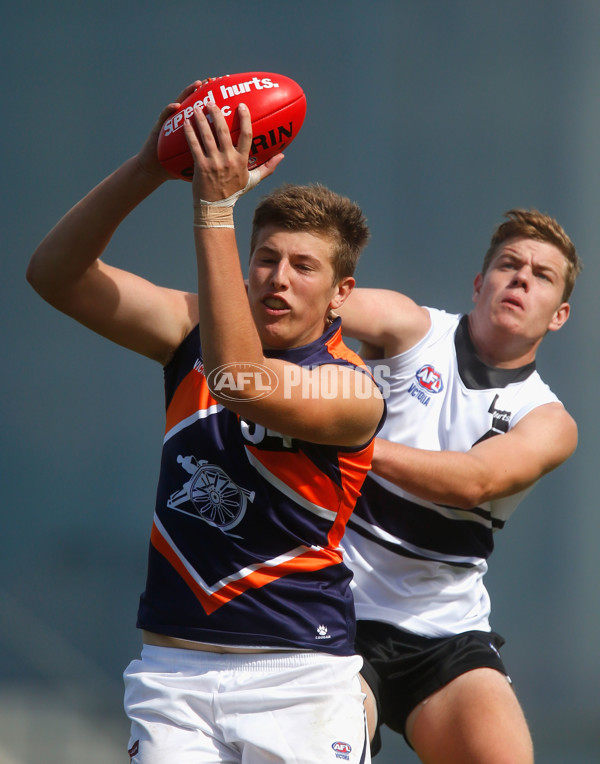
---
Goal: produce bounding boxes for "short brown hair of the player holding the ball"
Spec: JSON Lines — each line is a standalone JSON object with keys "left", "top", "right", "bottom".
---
{"left": 250, "top": 183, "right": 370, "bottom": 284}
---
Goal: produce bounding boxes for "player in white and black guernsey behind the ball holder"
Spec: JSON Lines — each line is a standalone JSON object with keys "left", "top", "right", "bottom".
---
{"left": 339, "top": 209, "right": 581, "bottom": 764}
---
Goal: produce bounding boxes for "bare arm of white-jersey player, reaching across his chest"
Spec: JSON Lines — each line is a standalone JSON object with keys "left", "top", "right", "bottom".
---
{"left": 373, "top": 403, "right": 577, "bottom": 509}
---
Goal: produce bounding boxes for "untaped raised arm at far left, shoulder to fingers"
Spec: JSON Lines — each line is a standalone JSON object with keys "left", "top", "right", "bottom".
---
{"left": 27, "top": 82, "right": 200, "bottom": 363}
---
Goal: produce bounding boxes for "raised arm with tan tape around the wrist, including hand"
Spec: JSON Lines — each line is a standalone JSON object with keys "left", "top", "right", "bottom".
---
{"left": 184, "top": 105, "right": 383, "bottom": 445}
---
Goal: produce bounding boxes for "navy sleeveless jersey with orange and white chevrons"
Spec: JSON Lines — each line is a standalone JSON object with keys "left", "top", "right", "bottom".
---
{"left": 138, "top": 319, "right": 382, "bottom": 655}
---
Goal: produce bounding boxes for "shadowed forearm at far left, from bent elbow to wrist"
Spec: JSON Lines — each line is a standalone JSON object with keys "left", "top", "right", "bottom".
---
{"left": 27, "top": 157, "right": 165, "bottom": 303}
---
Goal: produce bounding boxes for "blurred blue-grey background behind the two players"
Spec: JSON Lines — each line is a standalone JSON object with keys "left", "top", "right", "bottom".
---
{"left": 0, "top": 0, "right": 600, "bottom": 764}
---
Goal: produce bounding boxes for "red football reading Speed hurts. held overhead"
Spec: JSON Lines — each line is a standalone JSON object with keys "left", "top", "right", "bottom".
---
{"left": 158, "top": 72, "right": 306, "bottom": 181}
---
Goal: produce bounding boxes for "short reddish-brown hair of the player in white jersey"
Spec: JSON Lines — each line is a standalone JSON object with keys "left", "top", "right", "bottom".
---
{"left": 481, "top": 209, "right": 583, "bottom": 302}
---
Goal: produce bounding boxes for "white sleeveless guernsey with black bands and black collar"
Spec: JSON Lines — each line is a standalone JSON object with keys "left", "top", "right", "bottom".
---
{"left": 342, "top": 308, "right": 558, "bottom": 637}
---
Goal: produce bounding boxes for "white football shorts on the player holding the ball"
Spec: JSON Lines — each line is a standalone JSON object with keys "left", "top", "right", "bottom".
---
{"left": 124, "top": 645, "right": 371, "bottom": 764}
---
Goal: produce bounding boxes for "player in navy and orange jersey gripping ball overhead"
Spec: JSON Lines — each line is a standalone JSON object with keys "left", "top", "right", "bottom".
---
{"left": 28, "top": 83, "right": 384, "bottom": 764}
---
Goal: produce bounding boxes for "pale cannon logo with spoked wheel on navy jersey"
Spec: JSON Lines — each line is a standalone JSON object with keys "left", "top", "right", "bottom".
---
{"left": 167, "top": 455, "right": 255, "bottom": 531}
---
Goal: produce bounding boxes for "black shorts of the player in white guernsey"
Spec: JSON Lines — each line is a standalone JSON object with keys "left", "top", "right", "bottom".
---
{"left": 356, "top": 621, "right": 508, "bottom": 756}
